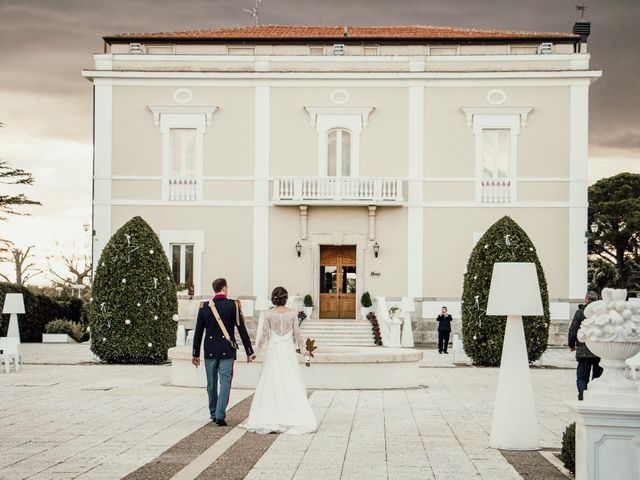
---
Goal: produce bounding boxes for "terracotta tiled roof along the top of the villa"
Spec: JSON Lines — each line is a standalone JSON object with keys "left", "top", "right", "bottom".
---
{"left": 104, "top": 25, "right": 579, "bottom": 43}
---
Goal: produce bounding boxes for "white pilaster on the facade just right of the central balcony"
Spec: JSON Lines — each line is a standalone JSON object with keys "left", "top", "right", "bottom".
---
{"left": 407, "top": 86, "right": 424, "bottom": 299}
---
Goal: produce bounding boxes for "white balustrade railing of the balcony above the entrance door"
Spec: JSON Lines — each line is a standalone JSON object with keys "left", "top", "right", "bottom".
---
{"left": 273, "top": 177, "right": 404, "bottom": 203}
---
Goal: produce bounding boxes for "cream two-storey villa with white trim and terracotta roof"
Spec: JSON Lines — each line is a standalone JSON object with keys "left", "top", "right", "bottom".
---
{"left": 83, "top": 22, "right": 601, "bottom": 341}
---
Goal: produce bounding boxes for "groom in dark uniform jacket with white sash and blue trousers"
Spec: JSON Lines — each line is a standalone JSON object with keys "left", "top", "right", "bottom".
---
{"left": 191, "top": 278, "right": 256, "bottom": 427}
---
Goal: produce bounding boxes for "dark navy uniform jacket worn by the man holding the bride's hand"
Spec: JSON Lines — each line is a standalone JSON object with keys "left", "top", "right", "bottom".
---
{"left": 193, "top": 295, "right": 253, "bottom": 360}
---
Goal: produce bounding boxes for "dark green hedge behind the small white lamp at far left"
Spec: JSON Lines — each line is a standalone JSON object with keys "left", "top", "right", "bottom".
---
{"left": 0, "top": 283, "right": 87, "bottom": 342}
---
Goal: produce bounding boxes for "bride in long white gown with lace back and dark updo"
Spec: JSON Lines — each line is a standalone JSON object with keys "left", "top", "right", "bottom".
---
{"left": 241, "top": 287, "right": 317, "bottom": 434}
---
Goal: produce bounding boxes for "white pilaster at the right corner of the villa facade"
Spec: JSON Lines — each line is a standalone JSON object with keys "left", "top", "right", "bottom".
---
{"left": 569, "top": 83, "right": 589, "bottom": 299}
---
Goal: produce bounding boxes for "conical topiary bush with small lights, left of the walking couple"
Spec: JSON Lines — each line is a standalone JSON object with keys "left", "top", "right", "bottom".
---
{"left": 89, "top": 217, "right": 178, "bottom": 364}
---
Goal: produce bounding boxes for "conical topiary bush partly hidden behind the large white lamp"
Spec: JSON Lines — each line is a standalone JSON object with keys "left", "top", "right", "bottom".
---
{"left": 462, "top": 216, "right": 550, "bottom": 366}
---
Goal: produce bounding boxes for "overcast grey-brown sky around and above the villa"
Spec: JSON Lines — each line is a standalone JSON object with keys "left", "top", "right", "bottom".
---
{"left": 0, "top": 0, "right": 640, "bottom": 284}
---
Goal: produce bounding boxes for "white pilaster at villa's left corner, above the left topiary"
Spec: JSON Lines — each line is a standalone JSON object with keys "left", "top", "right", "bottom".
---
{"left": 92, "top": 79, "right": 113, "bottom": 271}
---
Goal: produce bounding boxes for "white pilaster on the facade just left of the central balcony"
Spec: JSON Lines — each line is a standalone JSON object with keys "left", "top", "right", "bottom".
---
{"left": 253, "top": 86, "right": 271, "bottom": 298}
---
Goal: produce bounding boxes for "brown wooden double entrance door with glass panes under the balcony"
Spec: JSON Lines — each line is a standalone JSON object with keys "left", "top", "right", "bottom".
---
{"left": 320, "top": 245, "right": 356, "bottom": 318}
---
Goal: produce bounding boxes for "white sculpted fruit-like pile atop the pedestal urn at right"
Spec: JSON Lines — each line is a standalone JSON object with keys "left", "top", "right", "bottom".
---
{"left": 578, "top": 288, "right": 640, "bottom": 343}
